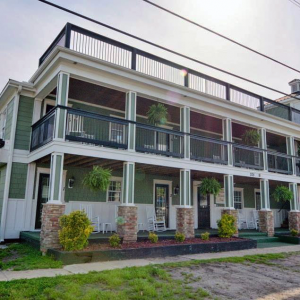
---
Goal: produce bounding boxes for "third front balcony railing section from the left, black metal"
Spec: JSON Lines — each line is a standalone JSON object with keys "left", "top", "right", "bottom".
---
{"left": 190, "top": 134, "right": 230, "bottom": 165}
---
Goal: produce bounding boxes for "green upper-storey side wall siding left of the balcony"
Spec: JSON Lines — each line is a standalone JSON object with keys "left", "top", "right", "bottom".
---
{"left": 15, "top": 96, "right": 34, "bottom": 150}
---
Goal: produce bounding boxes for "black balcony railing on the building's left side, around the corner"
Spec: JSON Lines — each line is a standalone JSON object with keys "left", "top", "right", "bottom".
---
{"left": 30, "top": 107, "right": 56, "bottom": 151}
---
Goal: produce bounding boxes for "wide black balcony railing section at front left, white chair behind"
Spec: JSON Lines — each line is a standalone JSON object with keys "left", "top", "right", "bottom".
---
{"left": 66, "top": 108, "right": 128, "bottom": 149}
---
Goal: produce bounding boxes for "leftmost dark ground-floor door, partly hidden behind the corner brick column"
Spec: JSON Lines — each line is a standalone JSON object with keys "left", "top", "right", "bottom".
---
{"left": 35, "top": 174, "right": 50, "bottom": 229}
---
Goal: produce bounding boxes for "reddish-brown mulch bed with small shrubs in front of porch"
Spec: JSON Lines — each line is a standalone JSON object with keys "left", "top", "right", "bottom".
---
{"left": 82, "top": 237, "right": 243, "bottom": 251}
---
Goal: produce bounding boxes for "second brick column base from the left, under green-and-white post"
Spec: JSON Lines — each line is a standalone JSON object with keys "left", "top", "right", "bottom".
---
{"left": 117, "top": 206, "right": 138, "bottom": 243}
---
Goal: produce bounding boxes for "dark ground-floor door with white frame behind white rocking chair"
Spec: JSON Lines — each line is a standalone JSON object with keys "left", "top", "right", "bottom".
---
{"left": 155, "top": 184, "right": 169, "bottom": 227}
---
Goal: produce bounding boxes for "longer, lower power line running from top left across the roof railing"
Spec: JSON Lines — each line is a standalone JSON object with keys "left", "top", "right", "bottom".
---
{"left": 37, "top": 0, "right": 300, "bottom": 100}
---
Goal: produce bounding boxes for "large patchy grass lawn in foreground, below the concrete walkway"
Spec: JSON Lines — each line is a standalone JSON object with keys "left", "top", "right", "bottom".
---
{"left": 0, "top": 254, "right": 290, "bottom": 300}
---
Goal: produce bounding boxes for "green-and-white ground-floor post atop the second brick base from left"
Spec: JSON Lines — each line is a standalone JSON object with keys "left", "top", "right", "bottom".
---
{"left": 122, "top": 162, "right": 135, "bottom": 206}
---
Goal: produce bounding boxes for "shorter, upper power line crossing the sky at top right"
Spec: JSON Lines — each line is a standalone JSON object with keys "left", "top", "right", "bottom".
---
{"left": 142, "top": 0, "right": 300, "bottom": 73}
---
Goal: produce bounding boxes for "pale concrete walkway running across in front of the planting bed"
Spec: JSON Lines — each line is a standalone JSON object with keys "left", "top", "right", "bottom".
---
{"left": 0, "top": 245, "right": 300, "bottom": 281}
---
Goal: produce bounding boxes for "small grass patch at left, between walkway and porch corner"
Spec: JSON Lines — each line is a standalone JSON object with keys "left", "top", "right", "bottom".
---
{"left": 0, "top": 243, "right": 62, "bottom": 272}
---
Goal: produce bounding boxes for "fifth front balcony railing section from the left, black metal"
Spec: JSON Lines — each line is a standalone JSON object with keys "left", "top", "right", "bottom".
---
{"left": 268, "top": 151, "right": 293, "bottom": 175}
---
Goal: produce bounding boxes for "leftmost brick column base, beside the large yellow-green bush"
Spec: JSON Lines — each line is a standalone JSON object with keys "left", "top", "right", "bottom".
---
{"left": 40, "top": 203, "right": 65, "bottom": 253}
